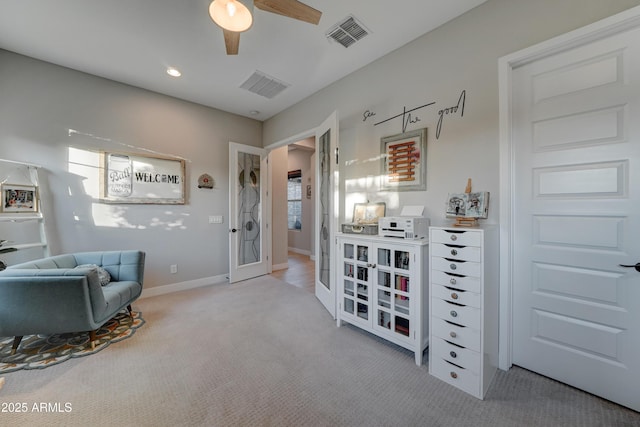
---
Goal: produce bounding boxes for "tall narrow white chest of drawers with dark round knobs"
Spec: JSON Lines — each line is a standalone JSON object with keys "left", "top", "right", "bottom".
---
{"left": 429, "top": 226, "right": 499, "bottom": 399}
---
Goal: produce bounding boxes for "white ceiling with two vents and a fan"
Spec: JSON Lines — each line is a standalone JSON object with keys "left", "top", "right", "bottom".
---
{"left": 0, "top": 0, "right": 486, "bottom": 120}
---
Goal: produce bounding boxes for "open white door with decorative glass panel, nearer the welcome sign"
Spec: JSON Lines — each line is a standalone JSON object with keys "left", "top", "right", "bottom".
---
{"left": 229, "top": 142, "right": 268, "bottom": 283}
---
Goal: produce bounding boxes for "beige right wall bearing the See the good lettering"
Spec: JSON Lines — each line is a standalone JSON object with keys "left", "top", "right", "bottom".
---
{"left": 264, "top": 0, "right": 640, "bottom": 227}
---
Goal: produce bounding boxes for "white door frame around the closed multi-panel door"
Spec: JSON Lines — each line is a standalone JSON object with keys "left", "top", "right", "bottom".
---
{"left": 498, "top": 6, "right": 640, "bottom": 370}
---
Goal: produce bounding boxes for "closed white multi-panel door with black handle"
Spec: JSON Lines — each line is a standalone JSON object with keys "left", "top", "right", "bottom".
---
{"left": 511, "top": 21, "right": 640, "bottom": 411}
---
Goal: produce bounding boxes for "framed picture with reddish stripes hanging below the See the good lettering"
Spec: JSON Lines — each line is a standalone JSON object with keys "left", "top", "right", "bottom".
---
{"left": 380, "top": 128, "right": 427, "bottom": 191}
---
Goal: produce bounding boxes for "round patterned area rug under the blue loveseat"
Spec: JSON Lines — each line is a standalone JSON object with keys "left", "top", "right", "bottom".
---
{"left": 0, "top": 311, "right": 144, "bottom": 375}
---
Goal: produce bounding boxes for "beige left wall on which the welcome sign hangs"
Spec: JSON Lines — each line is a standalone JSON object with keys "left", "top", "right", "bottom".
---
{"left": 0, "top": 50, "right": 262, "bottom": 289}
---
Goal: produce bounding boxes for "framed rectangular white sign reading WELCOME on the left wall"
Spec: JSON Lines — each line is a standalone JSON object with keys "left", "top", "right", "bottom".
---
{"left": 100, "top": 152, "right": 185, "bottom": 204}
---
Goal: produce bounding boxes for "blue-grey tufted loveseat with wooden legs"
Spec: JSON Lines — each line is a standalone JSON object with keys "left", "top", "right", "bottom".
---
{"left": 0, "top": 251, "right": 145, "bottom": 353}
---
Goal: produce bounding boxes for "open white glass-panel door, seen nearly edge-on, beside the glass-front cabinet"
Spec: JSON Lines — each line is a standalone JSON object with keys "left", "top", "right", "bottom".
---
{"left": 315, "top": 112, "right": 339, "bottom": 319}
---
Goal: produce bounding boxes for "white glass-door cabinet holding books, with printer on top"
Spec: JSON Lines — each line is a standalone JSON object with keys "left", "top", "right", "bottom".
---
{"left": 337, "top": 234, "right": 429, "bottom": 366}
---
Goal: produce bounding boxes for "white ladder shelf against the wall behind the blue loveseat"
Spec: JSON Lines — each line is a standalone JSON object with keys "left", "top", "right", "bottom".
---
{"left": 0, "top": 159, "right": 50, "bottom": 265}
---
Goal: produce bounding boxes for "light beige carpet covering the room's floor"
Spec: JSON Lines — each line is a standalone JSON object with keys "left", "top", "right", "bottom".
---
{"left": 0, "top": 276, "right": 640, "bottom": 427}
